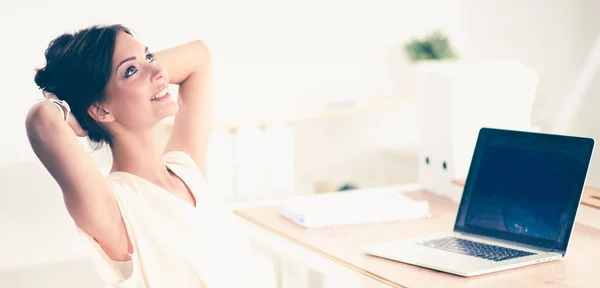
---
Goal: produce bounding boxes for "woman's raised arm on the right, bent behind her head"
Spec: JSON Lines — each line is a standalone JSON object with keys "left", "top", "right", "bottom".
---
{"left": 155, "top": 40, "right": 212, "bottom": 172}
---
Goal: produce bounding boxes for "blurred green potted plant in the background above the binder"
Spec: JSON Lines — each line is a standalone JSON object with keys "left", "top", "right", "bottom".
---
{"left": 404, "top": 30, "right": 458, "bottom": 62}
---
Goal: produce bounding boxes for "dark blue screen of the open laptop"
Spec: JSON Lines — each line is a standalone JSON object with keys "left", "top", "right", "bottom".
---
{"left": 455, "top": 128, "right": 594, "bottom": 253}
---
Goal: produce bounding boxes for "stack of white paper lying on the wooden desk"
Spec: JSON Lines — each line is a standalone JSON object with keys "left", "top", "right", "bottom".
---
{"left": 279, "top": 191, "right": 430, "bottom": 228}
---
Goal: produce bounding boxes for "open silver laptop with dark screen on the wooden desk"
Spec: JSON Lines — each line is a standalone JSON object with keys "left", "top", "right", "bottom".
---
{"left": 363, "top": 128, "right": 594, "bottom": 277}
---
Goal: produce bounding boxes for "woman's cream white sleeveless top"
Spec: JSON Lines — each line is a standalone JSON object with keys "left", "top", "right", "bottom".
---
{"left": 78, "top": 151, "right": 258, "bottom": 288}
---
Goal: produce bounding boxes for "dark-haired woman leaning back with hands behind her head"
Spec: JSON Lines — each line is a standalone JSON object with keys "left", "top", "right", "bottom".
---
{"left": 26, "top": 25, "right": 255, "bottom": 287}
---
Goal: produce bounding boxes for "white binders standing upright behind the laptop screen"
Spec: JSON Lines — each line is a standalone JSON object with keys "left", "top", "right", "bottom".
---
{"left": 416, "top": 61, "right": 538, "bottom": 200}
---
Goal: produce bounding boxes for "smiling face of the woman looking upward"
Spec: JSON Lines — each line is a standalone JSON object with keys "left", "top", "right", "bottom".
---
{"left": 103, "top": 32, "right": 178, "bottom": 131}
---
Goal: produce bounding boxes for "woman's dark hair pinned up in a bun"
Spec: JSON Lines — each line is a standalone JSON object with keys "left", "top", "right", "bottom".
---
{"left": 35, "top": 25, "right": 133, "bottom": 148}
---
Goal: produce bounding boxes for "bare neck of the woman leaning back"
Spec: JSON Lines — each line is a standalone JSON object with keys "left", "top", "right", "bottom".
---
{"left": 111, "top": 129, "right": 170, "bottom": 183}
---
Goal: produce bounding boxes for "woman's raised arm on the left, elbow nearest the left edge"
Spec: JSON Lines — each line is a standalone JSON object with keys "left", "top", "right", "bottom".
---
{"left": 25, "top": 101, "right": 131, "bottom": 260}
